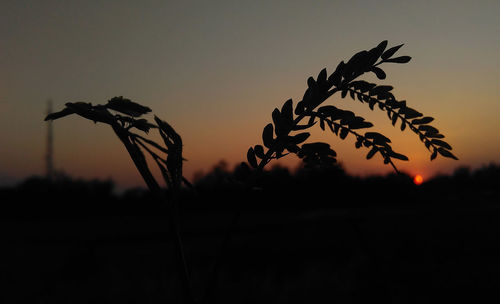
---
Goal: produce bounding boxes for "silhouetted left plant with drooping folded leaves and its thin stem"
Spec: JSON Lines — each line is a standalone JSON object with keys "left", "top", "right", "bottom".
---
{"left": 45, "top": 96, "right": 192, "bottom": 299}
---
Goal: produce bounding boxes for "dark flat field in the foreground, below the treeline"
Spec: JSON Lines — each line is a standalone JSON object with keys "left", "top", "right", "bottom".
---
{"left": 0, "top": 203, "right": 500, "bottom": 303}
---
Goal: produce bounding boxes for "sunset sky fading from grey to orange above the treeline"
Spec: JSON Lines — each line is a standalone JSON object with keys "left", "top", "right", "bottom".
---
{"left": 0, "top": 0, "right": 500, "bottom": 187}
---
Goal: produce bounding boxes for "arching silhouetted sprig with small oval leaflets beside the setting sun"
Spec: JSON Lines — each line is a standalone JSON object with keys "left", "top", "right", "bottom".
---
{"left": 247, "top": 41, "right": 457, "bottom": 172}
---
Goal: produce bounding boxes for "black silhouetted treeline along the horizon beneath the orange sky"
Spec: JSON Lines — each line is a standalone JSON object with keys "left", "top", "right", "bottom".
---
{"left": 0, "top": 162, "right": 500, "bottom": 217}
